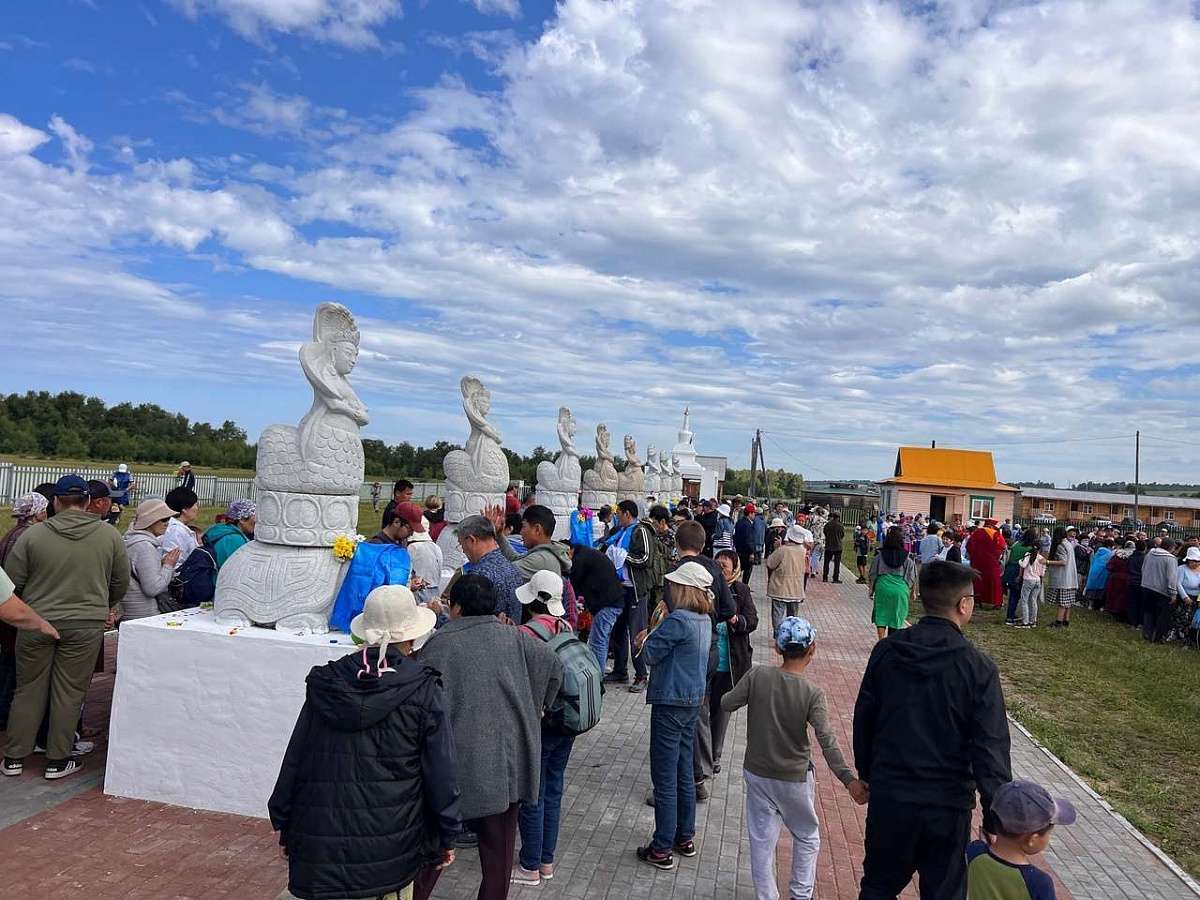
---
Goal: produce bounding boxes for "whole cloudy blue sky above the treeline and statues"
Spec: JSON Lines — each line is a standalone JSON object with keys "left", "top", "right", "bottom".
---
{"left": 0, "top": 0, "right": 1200, "bottom": 484}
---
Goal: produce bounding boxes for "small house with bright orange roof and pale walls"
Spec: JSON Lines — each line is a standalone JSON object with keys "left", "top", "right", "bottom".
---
{"left": 877, "top": 446, "right": 1020, "bottom": 524}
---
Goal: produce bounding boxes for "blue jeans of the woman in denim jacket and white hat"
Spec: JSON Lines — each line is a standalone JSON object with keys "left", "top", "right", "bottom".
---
{"left": 650, "top": 703, "right": 700, "bottom": 851}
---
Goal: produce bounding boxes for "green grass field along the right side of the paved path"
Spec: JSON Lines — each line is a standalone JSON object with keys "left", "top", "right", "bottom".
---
{"left": 842, "top": 532, "right": 1200, "bottom": 876}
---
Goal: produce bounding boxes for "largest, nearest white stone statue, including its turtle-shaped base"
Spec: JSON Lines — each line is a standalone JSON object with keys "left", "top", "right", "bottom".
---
{"left": 214, "top": 304, "right": 367, "bottom": 634}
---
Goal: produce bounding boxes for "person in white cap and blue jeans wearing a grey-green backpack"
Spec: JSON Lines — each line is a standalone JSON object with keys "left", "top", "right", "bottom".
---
{"left": 512, "top": 569, "right": 602, "bottom": 884}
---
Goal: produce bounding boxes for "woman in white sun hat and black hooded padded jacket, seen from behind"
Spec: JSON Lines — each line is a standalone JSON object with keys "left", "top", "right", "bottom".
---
{"left": 268, "top": 584, "right": 462, "bottom": 900}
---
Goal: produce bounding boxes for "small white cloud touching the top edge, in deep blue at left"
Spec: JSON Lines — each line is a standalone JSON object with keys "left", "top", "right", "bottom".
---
{"left": 170, "top": 0, "right": 401, "bottom": 48}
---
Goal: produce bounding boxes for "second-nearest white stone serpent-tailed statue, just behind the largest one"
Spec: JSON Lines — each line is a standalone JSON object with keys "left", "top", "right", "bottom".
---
{"left": 442, "top": 376, "right": 509, "bottom": 523}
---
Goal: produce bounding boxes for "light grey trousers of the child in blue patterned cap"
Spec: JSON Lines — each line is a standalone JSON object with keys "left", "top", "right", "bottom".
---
{"left": 743, "top": 768, "right": 821, "bottom": 900}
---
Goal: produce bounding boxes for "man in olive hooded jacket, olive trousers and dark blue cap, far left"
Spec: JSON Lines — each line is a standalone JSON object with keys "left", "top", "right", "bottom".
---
{"left": 4, "top": 475, "right": 130, "bottom": 779}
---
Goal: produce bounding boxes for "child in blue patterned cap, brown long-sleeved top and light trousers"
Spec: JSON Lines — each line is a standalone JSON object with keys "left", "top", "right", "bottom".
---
{"left": 721, "top": 616, "right": 868, "bottom": 900}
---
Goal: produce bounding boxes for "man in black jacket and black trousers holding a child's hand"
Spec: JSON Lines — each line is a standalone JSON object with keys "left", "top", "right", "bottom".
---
{"left": 854, "top": 560, "right": 1013, "bottom": 900}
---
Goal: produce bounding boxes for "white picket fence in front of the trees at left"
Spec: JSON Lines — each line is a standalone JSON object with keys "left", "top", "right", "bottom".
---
{"left": 0, "top": 460, "right": 445, "bottom": 506}
